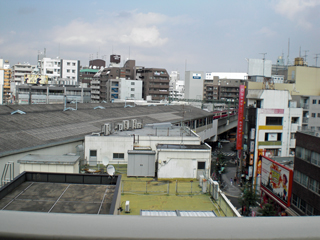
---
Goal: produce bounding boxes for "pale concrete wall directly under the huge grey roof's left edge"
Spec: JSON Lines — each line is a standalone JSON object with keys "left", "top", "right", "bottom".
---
{"left": 0, "top": 141, "right": 83, "bottom": 177}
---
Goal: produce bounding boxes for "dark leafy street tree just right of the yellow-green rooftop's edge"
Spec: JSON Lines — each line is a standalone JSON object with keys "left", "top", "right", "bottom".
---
{"left": 239, "top": 183, "right": 260, "bottom": 216}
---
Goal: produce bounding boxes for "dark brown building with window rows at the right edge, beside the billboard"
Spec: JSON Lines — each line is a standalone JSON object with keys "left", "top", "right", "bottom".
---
{"left": 291, "top": 131, "right": 320, "bottom": 216}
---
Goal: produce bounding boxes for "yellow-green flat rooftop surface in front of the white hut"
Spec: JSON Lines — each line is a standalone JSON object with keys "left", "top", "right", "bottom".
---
{"left": 115, "top": 165, "right": 225, "bottom": 217}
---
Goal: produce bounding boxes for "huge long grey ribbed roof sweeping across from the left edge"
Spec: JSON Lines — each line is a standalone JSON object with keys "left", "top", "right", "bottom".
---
{"left": 0, "top": 103, "right": 211, "bottom": 157}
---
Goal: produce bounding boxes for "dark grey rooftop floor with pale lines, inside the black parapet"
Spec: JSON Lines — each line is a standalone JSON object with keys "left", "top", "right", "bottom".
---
{"left": 0, "top": 181, "right": 115, "bottom": 214}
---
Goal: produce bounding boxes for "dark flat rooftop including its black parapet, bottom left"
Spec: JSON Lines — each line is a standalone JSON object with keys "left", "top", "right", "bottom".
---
{"left": 0, "top": 172, "right": 121, "bottom": 214}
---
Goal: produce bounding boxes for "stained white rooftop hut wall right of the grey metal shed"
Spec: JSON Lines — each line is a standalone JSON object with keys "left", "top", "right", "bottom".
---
{"left": 158, "top": 149, "right": 211, "bottom": 178}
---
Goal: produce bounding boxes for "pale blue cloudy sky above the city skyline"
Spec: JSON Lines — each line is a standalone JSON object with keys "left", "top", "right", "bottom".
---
{"left": 0, "top": 0, "right": 320, "bottom": 76}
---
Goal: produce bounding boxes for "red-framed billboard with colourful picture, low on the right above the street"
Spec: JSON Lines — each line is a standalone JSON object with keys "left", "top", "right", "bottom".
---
{"left": 261, "top": 156, "right": 293, "bottom": 207}
